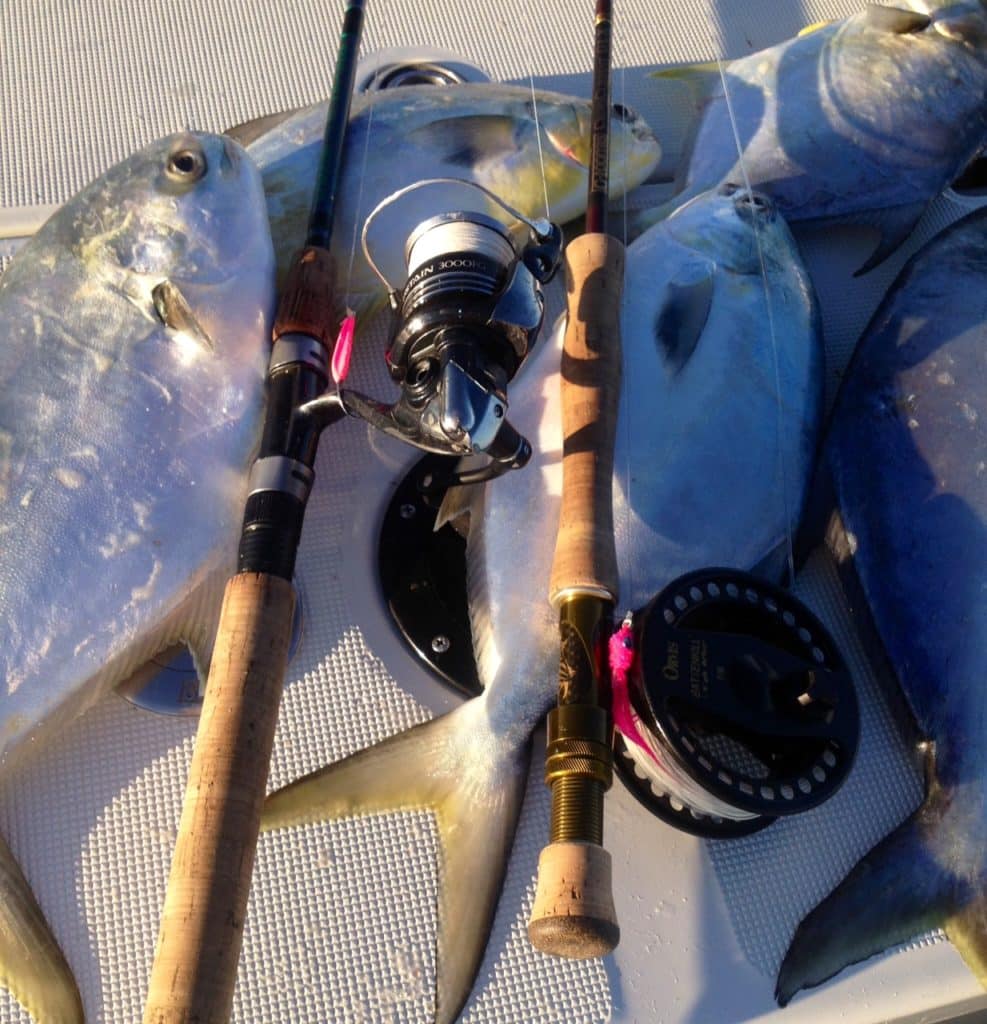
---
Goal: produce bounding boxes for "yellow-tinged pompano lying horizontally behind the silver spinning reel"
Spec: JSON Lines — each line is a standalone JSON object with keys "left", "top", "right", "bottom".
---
{"left": 230, "top": 83, "right": 660, "bottom": 309}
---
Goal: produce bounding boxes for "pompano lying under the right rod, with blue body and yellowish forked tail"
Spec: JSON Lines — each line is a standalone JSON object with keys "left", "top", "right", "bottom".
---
{"left": 263, "top": 186, "right": 822, "bottom": 1022}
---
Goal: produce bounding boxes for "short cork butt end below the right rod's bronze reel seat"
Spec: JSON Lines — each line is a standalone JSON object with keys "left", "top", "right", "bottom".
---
{"left": 527, "top": 842, "right": 620, "bottom": 959}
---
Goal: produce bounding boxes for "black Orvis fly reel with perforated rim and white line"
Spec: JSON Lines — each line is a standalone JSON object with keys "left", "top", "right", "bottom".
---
{"left": 614, "top": 569, "right": 859, "bottom": 838}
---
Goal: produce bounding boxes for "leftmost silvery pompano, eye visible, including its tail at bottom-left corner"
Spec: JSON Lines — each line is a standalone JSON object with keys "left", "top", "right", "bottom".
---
{"left": 0, "top": 135, "right": 274, "bottom": 1024}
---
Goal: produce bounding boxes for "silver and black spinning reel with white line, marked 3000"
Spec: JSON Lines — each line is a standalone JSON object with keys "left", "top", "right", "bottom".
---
{"left": 332, "top": 178, "right": 562, "bottom": 483}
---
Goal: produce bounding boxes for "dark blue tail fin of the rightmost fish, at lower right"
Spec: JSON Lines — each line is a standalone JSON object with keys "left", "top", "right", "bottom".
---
{"left": 775, "top": 783, "right": 958, "bottom": 1006}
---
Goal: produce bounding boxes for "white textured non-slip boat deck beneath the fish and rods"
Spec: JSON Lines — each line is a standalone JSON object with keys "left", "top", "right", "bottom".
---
{"left": 0, "top": 0, "right": 974, "bottom": 1024}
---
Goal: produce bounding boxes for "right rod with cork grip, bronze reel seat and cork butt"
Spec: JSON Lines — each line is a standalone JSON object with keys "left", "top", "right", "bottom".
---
{"left": 528, "top": 0, "right": 624, "bottom": 958}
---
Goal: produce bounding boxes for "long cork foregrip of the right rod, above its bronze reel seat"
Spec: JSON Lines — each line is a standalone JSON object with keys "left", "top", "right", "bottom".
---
{"left": 549, "top": 233, "right": 624, "bottom": 605}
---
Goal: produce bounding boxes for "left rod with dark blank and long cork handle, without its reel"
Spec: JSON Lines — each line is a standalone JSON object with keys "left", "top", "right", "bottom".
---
{"left": 143, "top": 0, "right": 364, "bottom": 1024}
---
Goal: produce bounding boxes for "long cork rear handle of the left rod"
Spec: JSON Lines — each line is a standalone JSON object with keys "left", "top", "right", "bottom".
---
{"left": 143, "top": 573, "right": 295, "bottom": 1024}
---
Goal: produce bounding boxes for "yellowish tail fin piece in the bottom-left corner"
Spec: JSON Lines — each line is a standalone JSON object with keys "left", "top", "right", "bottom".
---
{"left": 0, "top": 839, "right": 85, "bottom": 1024}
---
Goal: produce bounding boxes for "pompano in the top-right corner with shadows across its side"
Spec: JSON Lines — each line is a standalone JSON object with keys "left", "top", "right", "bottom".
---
{"left": 640, "top": 0, "right": 987, "bottom": 272}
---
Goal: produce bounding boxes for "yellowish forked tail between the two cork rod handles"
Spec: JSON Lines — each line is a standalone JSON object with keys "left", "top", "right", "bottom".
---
{"left": 261, "top": 697, "right": 529, "bottom": 1024}
